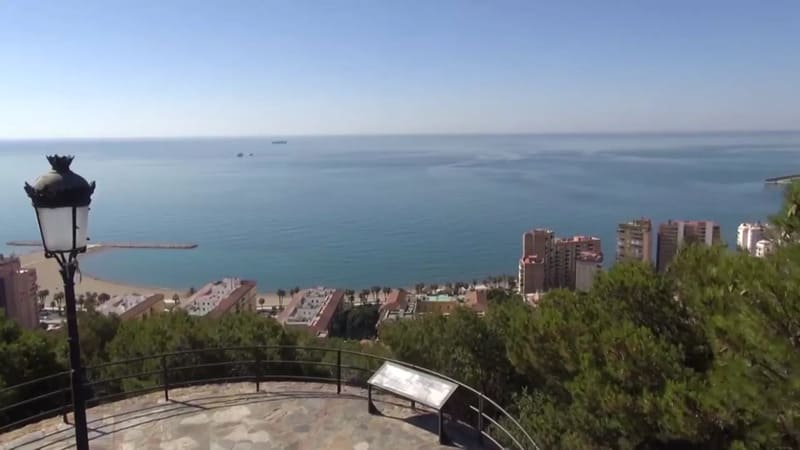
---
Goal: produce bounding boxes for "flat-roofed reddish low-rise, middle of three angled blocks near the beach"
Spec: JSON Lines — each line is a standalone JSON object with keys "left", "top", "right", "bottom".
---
{"left": 184, "top": 278, "right": 256, "bottom": 317}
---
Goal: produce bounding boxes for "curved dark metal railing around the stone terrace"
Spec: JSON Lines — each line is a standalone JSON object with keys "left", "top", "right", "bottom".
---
{"left": 0, "top": 345, "right": 539, "bottom": 450}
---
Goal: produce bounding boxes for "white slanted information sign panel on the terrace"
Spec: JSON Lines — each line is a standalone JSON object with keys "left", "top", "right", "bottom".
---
{"left": 368, "top": 361, "right": 458, "bottom": 409}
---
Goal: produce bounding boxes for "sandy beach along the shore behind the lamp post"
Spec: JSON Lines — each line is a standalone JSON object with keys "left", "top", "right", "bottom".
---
{"left": 19, "top": 247, "right": 289, "bottom": 306}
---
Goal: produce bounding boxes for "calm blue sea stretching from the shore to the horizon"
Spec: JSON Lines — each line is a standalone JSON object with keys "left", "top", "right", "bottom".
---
{"left": 0, "top": 132, "right": 800, "bottom": 291}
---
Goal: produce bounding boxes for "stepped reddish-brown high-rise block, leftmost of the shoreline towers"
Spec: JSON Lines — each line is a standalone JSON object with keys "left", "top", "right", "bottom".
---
{"left": 518, "top": 228, "right": 602, "bottom": 295}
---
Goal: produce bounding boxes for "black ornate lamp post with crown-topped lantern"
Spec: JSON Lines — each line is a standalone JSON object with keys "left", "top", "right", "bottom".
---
{"left": 25, "top": 155, "right": 95, "bottom": 450}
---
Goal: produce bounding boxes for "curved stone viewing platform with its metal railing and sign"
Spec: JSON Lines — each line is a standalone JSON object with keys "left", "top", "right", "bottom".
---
{"left": 0, "top": 345, "right": 540, "bottom": 450}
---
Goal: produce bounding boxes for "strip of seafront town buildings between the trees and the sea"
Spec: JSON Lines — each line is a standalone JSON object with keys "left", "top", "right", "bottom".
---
{"left": 0, "top": 218, "right": 772, "bottom": 337}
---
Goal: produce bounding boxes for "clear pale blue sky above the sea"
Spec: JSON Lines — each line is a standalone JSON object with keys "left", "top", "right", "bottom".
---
{"left": 0, "top": 0, "right": 800, "bottom": 139}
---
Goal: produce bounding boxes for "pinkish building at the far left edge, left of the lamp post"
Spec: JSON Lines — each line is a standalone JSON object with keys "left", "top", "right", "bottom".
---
{"left": 0, "top": 254, "right": 39, "bottom": 328}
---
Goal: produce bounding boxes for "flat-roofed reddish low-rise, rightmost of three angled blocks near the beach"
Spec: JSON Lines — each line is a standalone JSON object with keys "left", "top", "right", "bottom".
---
{"left": 278, "top": 287, "right": 344, "bottom": 337}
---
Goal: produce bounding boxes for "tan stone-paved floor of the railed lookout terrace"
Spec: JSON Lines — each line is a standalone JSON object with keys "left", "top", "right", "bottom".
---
{"left": 0, "top": 382, "right": 483, "bottom": 450}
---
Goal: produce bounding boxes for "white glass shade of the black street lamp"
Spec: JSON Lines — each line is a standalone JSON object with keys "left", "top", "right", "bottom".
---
{"left": 36, "top": 205, "right": 89, "bottom": 252}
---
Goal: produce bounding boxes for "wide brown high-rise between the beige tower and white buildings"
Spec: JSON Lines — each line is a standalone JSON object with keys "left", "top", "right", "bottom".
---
{"left": 656, "top": 220, "right": 722, "bottom": 272}
